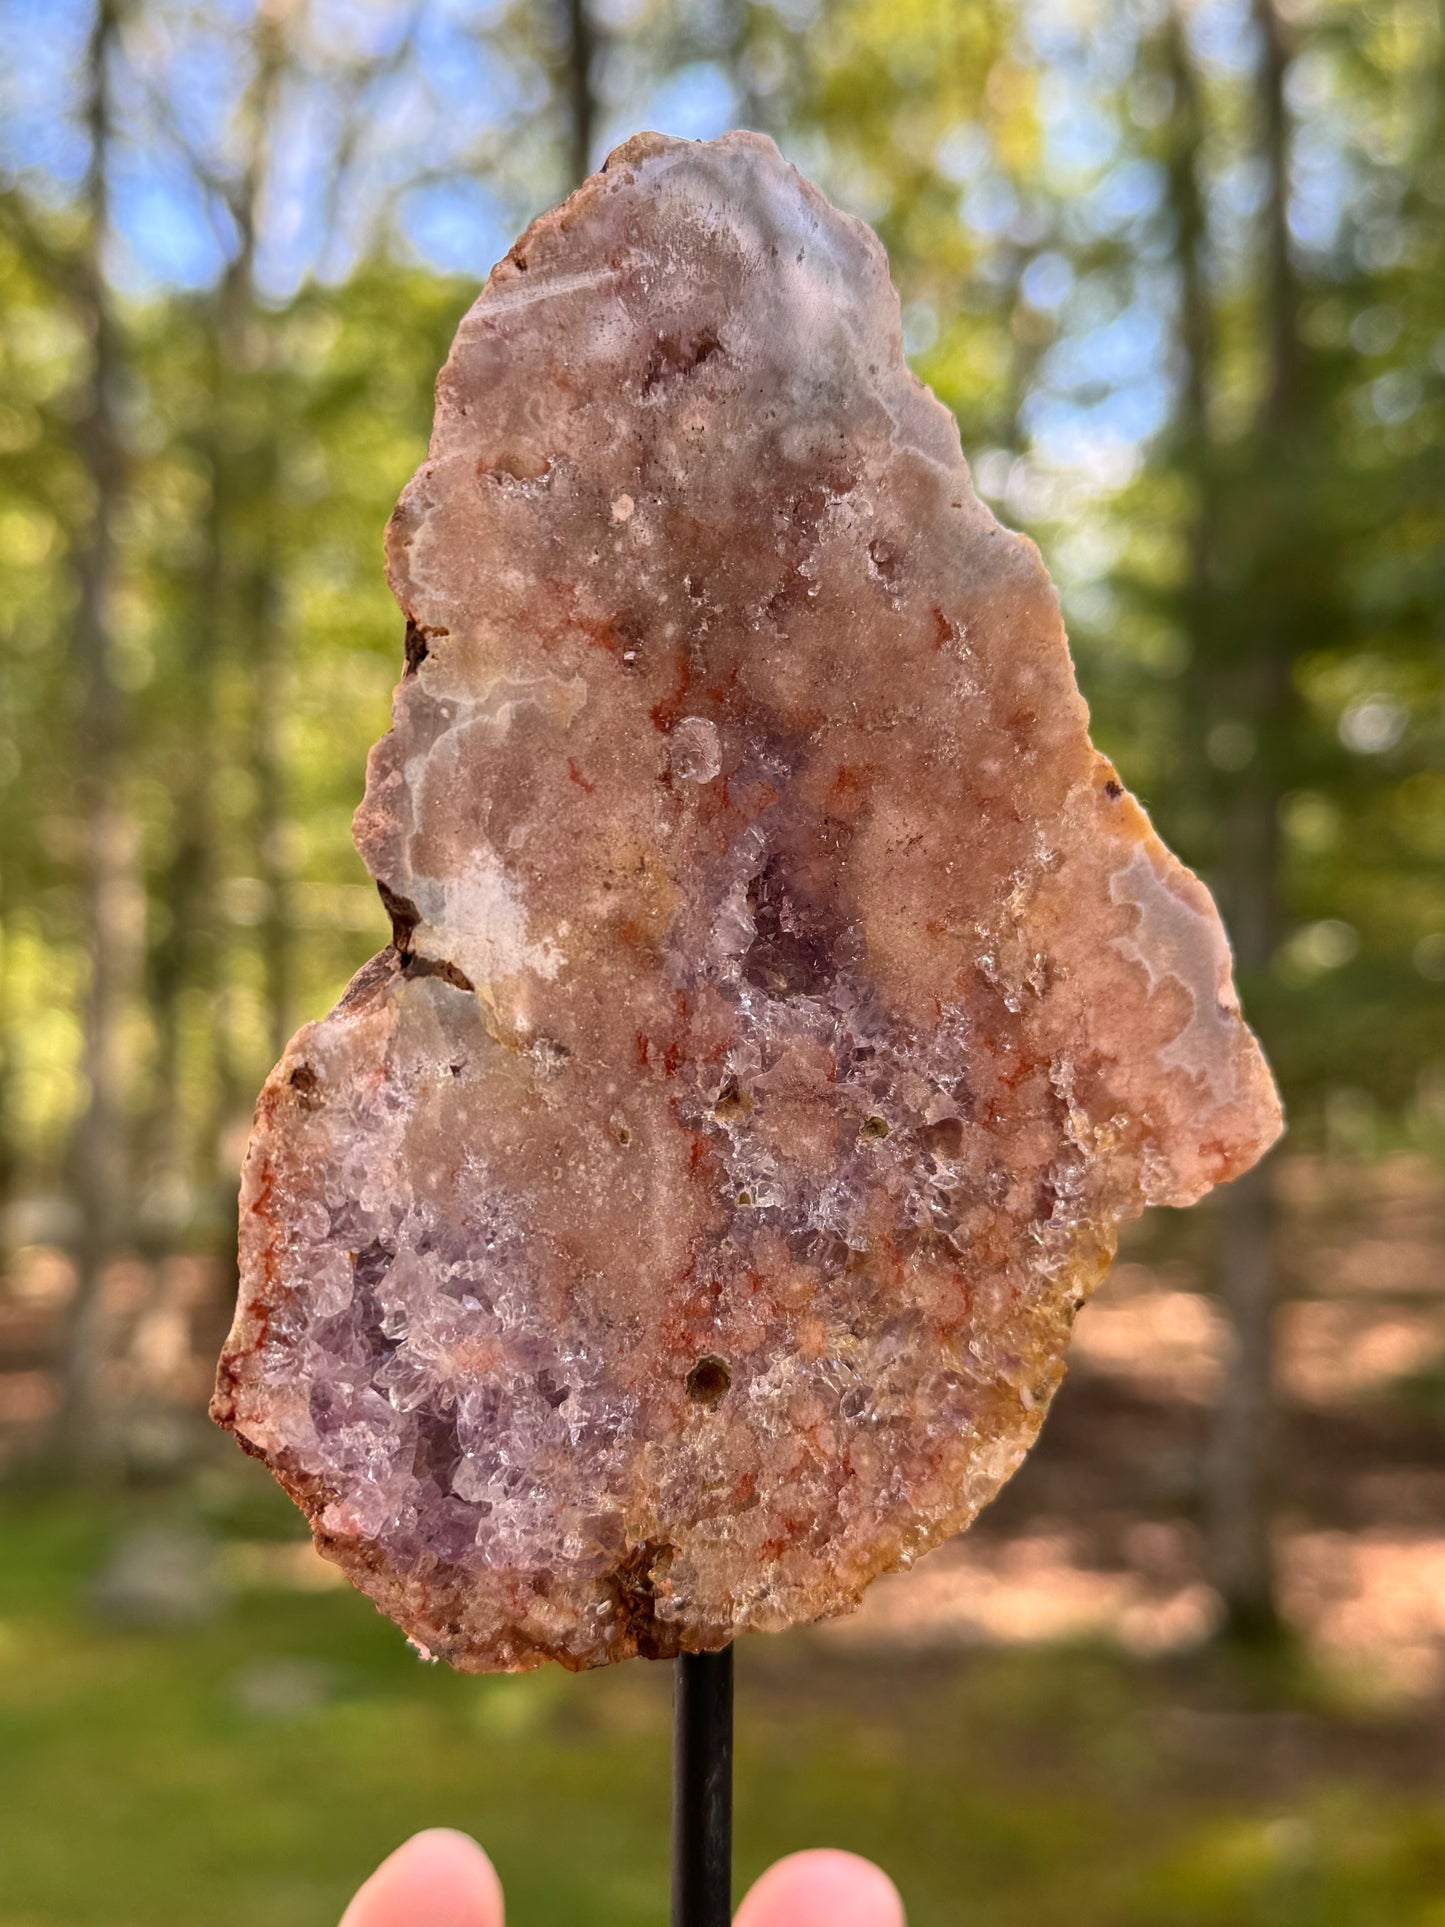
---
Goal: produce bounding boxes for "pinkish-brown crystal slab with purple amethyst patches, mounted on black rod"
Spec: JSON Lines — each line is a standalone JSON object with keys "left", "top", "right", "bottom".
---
{"left": 216, "top": 135, "right": 1279, "bottom": 1669}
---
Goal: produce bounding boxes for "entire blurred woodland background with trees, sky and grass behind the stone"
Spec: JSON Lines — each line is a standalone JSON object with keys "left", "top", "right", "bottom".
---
{"left": 0, "top": 0, "right": 1445, "bottom": 1927}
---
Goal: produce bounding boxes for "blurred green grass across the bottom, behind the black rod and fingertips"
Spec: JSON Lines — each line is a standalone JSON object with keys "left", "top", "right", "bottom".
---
{"left": 0, "top": 1478, "right": 1445, "bottom": 1927}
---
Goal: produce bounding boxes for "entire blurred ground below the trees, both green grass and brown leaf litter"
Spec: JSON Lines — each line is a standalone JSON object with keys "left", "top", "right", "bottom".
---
{"left": 0, "top": 1160, "right": 1445, "bottom": 1927}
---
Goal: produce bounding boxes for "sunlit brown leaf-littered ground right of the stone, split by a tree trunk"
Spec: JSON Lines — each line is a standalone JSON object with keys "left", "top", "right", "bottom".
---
{"left": 838, "top": 1158, "right": 1445, "bottom": 1703}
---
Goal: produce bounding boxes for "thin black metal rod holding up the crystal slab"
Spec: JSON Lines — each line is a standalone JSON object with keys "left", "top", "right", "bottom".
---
{"left": 672, "top": 1646, "right": 732, "bottom": 1927}
